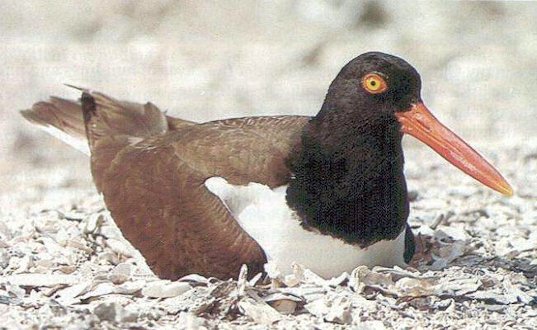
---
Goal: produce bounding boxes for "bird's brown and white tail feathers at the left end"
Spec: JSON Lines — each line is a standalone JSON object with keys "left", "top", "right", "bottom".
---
{"left": 21, "top": 86, "right": 194, "bottom": 188}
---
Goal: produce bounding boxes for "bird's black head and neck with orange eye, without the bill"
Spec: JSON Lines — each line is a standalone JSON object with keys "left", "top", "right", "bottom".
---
{"left": 286, "top": 52, "right": 421, "bottom": 246}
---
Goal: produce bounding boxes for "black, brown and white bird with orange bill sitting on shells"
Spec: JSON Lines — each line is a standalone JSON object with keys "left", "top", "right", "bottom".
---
{"left": 21, "top": 52, "right": 513, "bottom": 280}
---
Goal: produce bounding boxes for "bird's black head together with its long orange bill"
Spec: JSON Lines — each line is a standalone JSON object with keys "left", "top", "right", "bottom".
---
{"left": 319, "top": 52, "right": 513, "bottom": 195}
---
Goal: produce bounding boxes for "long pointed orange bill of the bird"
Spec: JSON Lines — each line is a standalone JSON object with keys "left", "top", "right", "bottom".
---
{"left": 395, "top": 102, "right": 513, "bottom": 196}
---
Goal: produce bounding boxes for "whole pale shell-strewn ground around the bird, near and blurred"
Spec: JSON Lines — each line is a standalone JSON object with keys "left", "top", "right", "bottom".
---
{"left": 0, "top": 0, "right": 537, "bottom": 329}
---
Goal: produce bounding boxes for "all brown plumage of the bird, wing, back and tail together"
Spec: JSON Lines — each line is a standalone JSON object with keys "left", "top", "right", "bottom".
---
{"left": 22, "top": 87, "right": 309, "bottom": 279}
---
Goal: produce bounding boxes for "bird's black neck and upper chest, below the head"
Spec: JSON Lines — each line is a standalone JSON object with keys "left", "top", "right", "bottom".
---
{"left": 287, "top": 111, "right": 408, "bottom": 247}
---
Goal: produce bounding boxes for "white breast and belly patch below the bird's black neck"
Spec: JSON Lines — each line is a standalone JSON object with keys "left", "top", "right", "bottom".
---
{"left": 205, "top": 177, "right": 406, "bottom": 278}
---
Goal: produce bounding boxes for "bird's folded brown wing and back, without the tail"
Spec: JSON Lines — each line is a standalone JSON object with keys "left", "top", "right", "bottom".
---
{"left": 101, "top": 116, "right": 308, "bottom": 279}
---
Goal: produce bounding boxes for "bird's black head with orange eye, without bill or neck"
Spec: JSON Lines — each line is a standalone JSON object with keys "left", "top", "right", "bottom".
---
{"left": 320, "top": 52, "right": 421, "bottom": 117}
